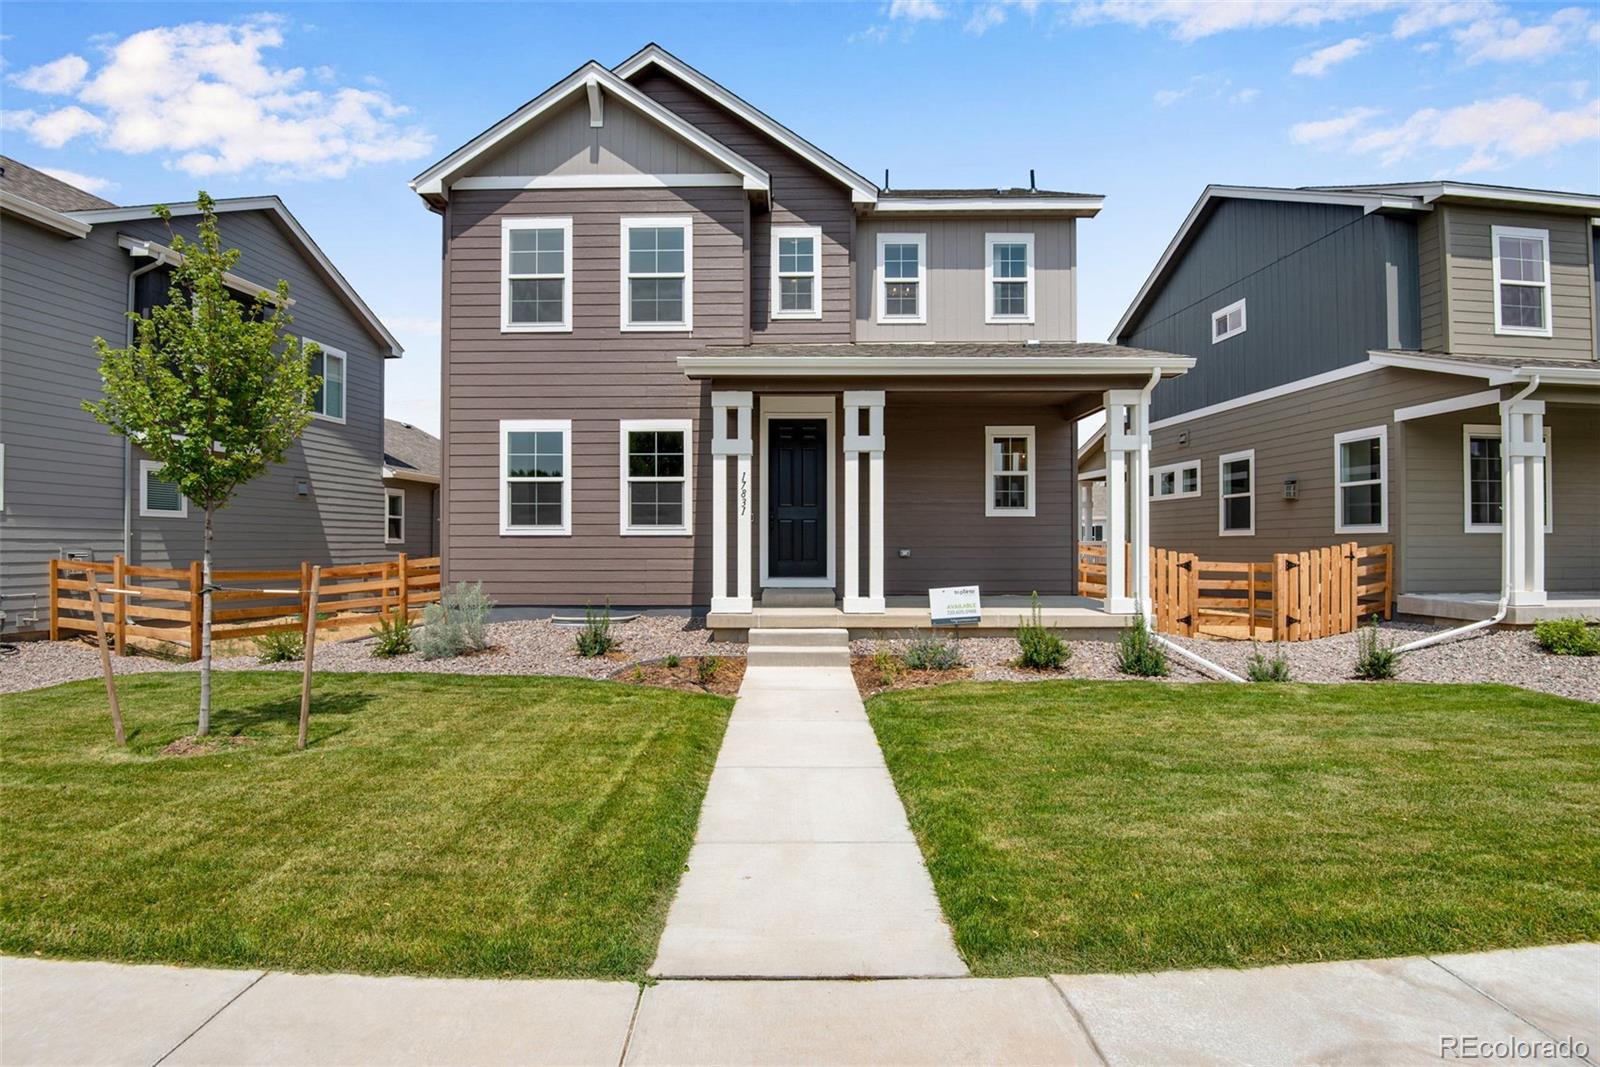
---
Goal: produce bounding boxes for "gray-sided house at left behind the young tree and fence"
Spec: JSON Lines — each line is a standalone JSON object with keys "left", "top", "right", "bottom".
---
{"left": 0, "top": 157, "right": 400, "bottom": 633}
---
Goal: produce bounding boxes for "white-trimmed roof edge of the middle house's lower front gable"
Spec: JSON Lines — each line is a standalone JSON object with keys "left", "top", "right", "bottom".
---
{"left": 411, "top": 59, "right": 771, "bottom": 202}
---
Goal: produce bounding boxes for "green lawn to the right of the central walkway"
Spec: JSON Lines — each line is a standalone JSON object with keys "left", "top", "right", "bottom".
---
{"left": 867, "top": 681, "right": 1600, "bottom": 974}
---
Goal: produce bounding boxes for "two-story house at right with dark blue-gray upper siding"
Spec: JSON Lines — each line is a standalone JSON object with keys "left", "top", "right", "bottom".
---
{"left": 1114, "top": 181, "right": 1600, "bottom": 622}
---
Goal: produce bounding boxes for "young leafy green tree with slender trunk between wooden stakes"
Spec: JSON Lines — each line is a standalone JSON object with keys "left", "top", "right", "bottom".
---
{"left": 83, "top": 192, "right": 322, "bottom": 736}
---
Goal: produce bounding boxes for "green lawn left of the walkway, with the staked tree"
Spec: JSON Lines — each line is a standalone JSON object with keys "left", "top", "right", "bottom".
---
{"left": 0, "top": 672, "right": 731, "bottom": 977}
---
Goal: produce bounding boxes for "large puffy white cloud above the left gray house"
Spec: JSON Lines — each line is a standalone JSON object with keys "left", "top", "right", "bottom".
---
{"left": 6, "top": 14, "right": 434, "bottom": 179}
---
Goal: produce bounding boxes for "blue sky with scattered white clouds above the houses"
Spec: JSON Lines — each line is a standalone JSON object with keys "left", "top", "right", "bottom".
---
{"left": 0, "top": 0, "right": 1600, "bottom": 430}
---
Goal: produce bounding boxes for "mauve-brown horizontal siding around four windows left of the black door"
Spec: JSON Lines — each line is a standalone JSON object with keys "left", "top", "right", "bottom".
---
{"left": 440, "top": 187, "right": 749, "bottom": 606}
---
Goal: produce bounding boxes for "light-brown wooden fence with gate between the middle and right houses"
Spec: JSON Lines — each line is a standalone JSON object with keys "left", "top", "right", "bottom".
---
{"left": 1078, "top": 541, "right": 1394, "bottom": 641}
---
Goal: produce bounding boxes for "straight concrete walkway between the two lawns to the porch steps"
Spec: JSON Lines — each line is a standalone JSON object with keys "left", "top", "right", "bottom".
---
{"left": 651, "top": 665, "right": 966, "bottom": 977}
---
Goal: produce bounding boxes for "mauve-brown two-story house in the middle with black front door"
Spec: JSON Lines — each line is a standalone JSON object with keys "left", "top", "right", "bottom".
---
{"left": 413, "top": 45, "right": 1190, "bottom": 630}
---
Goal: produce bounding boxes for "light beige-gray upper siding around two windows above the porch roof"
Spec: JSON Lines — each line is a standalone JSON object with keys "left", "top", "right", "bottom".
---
{"left": 856, "top": 218, "right": 1077, "bottom": 341}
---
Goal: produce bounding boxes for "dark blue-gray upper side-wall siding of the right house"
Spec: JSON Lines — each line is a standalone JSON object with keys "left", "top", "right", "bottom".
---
{"left": 1118, "top": 200, "right": 1421, "bottom": 419}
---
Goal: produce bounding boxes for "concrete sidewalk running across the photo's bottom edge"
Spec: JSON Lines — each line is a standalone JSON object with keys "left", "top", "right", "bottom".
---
{"left": 0, "top": 944, "right": 1600, "bottom": 1067}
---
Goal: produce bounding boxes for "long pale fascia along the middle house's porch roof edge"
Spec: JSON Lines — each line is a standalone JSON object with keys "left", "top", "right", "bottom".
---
{"left": 678, "top": 355, "right": 1195, "bottom": 378}
